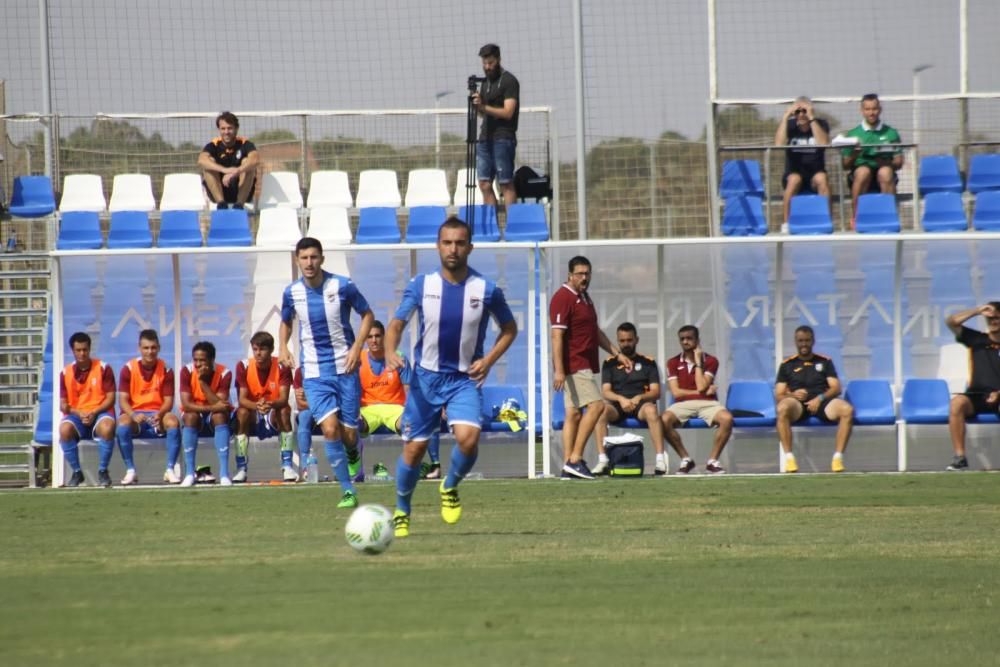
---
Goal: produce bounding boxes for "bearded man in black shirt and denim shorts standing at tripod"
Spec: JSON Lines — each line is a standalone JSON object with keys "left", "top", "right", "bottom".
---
{"left": 472, "top": 44, "right": 521, "bottom": 206}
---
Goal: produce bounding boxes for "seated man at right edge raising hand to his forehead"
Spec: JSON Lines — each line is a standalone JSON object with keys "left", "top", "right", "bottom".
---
{"left": 945, "top": 301, "right": 1000, "bottom": 470}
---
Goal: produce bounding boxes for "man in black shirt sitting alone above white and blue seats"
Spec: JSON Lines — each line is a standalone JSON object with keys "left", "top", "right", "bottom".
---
{"left": 198, "top": 111, "right": 260, "bottom": 208}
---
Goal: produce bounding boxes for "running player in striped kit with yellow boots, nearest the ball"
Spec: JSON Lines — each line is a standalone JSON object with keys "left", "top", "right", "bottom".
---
{"left": 385, "top": 216, "right": 517, "bottom": 537}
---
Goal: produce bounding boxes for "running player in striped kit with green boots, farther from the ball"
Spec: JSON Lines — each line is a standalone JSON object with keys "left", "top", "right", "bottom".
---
{"left": 278, "top": 236, "right": 375, "bottom": 508}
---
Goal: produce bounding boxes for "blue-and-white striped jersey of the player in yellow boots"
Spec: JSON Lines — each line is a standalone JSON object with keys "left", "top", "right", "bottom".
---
{"left": 393, "top": 268, "right": 514, "bottom": 373}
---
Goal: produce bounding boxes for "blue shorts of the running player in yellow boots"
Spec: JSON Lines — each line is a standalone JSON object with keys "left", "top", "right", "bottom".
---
{"left": 403, "top": 366, "right": 483, "bottom": 440}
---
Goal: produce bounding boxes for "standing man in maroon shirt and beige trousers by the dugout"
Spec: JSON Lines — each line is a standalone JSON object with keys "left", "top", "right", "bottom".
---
{"left": 549, "top": 256, "right": 632, "bottom": 479}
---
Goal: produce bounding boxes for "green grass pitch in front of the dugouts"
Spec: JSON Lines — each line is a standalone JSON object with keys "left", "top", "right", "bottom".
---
{"left": 0, "top": 473, "right": 1000, "bottom": 667}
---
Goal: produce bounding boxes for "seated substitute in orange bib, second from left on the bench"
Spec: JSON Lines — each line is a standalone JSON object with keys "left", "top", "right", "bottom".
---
{"left": 118, "top": 329, "right": 181, "bottom": 486}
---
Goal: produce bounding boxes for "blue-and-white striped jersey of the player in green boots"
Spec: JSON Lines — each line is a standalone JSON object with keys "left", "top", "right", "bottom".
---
{"left": 281, "top": 271, "right": 370, "bottom": 378}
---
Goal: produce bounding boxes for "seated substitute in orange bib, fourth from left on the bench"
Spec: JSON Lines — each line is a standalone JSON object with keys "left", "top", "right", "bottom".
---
{"left": 233, "top": 331, "right": 299, "bottom": 482}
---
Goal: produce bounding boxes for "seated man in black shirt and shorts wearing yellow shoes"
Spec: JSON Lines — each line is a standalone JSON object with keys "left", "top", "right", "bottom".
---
{"left": 774, "top": 325, "right": 854, "bottom": 472}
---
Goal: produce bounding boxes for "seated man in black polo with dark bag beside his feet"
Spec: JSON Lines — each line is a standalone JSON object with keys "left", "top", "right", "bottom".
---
{"left": 591, "top": 322, "right": 667, "bottom": 475}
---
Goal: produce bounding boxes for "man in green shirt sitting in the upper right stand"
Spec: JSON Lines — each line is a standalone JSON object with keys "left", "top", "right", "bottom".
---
{"left": 841, "top": 93, "right": 903, "bottom": 226}
